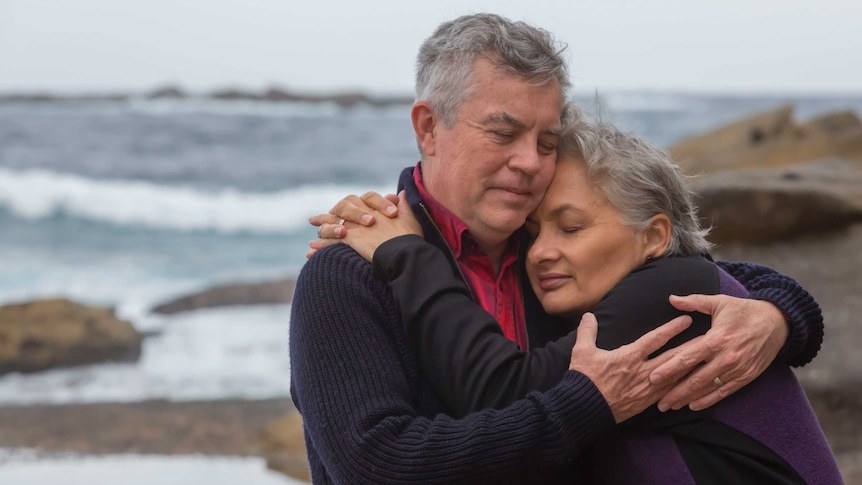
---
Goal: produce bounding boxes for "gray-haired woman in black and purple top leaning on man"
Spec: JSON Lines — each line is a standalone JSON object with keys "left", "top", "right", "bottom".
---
{"left": 314, "top": 111, "right": 841, "bottom": 484}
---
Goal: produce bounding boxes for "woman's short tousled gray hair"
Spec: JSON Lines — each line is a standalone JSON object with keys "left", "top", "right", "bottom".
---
{"left": 557, "top": 105, "right": 712, "bottom": 256}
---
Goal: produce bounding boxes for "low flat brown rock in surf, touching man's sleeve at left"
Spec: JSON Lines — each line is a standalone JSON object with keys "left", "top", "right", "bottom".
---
{"left": 152, "top": 280, "right": 296, "bottom": 314}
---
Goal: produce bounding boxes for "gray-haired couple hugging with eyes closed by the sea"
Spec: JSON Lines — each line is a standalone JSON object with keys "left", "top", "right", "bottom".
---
{"left": 290, "top": 14, "right": 841, "bottom": 484}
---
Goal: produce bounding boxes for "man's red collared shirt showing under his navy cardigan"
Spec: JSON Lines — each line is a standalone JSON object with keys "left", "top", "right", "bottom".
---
{"left": 413, "top": 162, "right": 529, "bottom": 350}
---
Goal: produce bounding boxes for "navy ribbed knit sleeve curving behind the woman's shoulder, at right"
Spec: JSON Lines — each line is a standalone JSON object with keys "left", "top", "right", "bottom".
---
{"left": 717, "top": 261, "right": 823, "bottom": 367}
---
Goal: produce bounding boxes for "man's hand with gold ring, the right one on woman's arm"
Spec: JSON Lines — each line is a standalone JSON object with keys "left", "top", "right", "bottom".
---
{"left": 649, "top": 295, "right": 788, "bottom": 411}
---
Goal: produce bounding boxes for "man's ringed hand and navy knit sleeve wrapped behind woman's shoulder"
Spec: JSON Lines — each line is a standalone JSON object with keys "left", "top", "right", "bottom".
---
{"left": 650, "top": 263, "right": 823, "bottom": 410}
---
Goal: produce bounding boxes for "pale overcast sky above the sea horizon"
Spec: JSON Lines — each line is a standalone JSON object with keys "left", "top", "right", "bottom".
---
{"left": 0, "top": 0, "right": 862, "bottom": 93}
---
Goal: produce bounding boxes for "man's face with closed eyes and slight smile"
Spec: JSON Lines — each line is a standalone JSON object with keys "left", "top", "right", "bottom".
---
{"left": 423, "top": 57, "right": 562, "bottom": 244}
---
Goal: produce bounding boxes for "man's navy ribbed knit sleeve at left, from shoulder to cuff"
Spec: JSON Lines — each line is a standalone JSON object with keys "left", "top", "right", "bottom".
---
{"left": 290, "top": 245, "right": 614, "bottom": 484}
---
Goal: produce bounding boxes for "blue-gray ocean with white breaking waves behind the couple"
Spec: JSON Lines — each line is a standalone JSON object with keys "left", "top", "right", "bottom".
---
{"left": 0, "top": 92, "right": 862, "bottom": 405}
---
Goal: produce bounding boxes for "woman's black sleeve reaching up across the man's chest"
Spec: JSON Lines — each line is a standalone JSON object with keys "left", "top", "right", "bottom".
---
{"left": 373, "top": 236, "right": 575, "bottom": 416}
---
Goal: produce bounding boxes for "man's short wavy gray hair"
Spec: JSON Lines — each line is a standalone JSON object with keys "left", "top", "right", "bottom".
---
{"left": 416, "top": 14, "right": 569, "bottom": 127}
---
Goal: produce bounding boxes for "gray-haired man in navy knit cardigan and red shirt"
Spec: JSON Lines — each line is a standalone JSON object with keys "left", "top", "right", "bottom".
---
{"left": 290, "top": 15, "right": 822, "bottom": 483}
